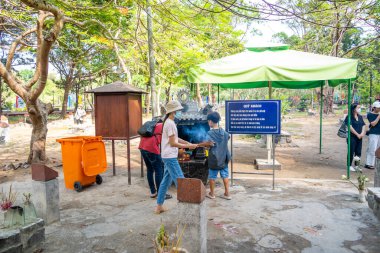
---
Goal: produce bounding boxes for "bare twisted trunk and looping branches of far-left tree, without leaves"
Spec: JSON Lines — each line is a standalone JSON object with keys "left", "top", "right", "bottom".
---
{"left": 0, "top": 0, "right": 64, "bottom": 162}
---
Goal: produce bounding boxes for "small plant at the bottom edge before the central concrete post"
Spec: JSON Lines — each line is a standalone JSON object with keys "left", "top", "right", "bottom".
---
{"left": 154, "top": 224, "right": 188, "bottom": 253}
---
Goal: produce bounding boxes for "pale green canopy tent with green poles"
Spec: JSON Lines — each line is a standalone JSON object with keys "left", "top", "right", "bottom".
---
{"left": 189, "top": 44, "right": 358, "bottom": 177}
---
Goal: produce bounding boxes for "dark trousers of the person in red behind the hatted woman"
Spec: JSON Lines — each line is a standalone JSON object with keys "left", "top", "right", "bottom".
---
{"left": 140, "top": 149, "right": 164, "bottom": 194}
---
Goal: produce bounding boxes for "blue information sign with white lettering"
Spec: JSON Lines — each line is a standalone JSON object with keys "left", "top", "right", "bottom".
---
{"left": 226, "top": 100, "right": 281, "bottom": 134}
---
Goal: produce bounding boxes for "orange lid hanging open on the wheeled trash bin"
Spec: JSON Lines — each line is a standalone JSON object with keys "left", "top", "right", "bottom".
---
{"left": 82, "top": 141, "right": 107, "bottom": 176}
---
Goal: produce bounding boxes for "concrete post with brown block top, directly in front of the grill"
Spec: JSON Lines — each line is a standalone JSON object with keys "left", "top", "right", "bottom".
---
{"left": 177, "top": 178, "right": 207, "bottom": 253}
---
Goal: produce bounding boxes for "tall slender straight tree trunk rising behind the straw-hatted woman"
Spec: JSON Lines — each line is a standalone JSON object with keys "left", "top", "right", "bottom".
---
{"left": 146, "top": 0, "right": 159, "bottom": 117}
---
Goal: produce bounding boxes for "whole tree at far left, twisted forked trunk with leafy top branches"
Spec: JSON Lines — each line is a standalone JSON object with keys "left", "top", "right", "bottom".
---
{"left": 0, "top": 0, "right": 127, "bottom": 162}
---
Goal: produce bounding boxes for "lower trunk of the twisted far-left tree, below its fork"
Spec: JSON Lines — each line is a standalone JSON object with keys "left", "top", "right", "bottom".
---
{"left": 26, "top": 99, "right": 53, "bottom": 163}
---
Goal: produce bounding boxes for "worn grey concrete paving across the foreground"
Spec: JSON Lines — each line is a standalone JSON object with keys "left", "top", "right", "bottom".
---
{"left": 4, "top": 172, "right": 380, "bottom": 253}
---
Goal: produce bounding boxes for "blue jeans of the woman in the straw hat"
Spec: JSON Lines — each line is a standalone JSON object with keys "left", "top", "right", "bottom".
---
{"left": 157, "top": 158, "right": 185, "bottom": 205}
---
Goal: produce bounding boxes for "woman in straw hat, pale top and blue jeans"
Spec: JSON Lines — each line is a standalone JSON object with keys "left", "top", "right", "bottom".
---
{"left": 155, "top": 101, "right": 197, "bottom": 214}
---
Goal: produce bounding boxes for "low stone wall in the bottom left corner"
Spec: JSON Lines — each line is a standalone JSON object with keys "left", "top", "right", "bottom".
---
{"left": 0, "top": 219, "right": 45, "bottom": 253}
